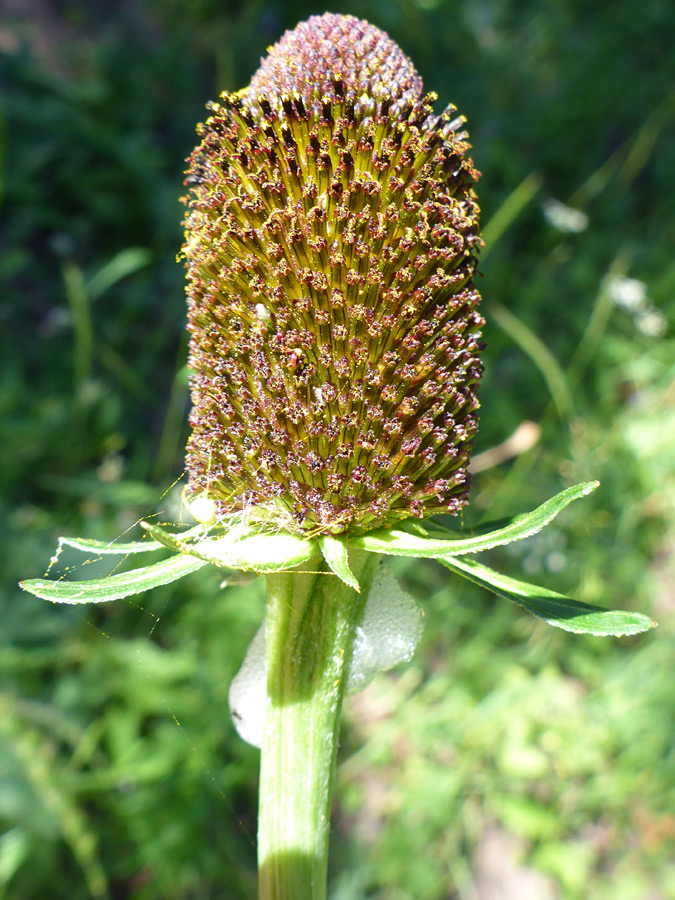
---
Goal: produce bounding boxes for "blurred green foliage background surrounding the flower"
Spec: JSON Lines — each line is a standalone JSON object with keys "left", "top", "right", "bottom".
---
{"left": 0, "top": 0, "right": 675, "bottom": 900}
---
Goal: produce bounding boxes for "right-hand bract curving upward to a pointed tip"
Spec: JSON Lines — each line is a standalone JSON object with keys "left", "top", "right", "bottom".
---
{"left": 349, "top": 481, "right": 599, "bottom": 561}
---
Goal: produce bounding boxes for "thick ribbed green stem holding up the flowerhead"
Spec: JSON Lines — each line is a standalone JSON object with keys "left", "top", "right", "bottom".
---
{"left": 258, "top": 552, "right": 378, "bottom": 900}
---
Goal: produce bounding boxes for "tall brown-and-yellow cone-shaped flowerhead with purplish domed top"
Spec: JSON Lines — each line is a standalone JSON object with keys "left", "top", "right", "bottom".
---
{"left": 183, "top": 14, "right": 483, "bottom": 536}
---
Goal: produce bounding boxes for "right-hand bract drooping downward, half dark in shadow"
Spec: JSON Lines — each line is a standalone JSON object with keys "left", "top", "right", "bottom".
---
{"left": 441, "top": 559, "right": 656, "bottom": 637}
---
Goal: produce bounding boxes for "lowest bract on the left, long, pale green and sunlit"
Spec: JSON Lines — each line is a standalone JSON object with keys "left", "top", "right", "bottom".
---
{"left": 20, "top": 556, "right": 204, "bottom": 603}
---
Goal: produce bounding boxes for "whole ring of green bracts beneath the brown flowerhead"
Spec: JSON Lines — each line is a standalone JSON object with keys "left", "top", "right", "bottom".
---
{"left": 21, "top": 482, "right": 656, "bottom": 637}
